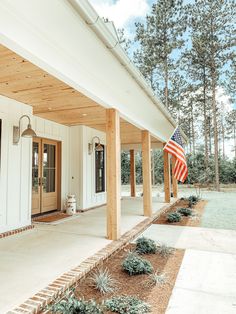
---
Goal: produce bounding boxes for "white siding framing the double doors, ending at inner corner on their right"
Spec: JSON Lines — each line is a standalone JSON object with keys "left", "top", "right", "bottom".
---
{"left": 0, "top": 96, "right": 70, "bottom": 233}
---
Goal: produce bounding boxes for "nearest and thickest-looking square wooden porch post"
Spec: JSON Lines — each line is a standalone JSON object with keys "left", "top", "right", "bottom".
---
{"left": 106, "top": 109, "right": 121, "bottom": 240}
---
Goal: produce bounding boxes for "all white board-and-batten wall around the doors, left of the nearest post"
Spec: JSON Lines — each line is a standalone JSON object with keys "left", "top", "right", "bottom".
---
{"left": 0, "top": 96, "right": 106, "bottom": 232}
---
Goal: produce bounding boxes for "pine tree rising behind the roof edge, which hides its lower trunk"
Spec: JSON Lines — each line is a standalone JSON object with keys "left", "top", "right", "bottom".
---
{"left": 134, "top": 0, "right": 185, "bottom": 108}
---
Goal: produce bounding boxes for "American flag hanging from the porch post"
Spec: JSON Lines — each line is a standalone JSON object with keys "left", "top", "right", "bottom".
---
{"left": 163, "top": 127, "right": 188, "bottom": 183}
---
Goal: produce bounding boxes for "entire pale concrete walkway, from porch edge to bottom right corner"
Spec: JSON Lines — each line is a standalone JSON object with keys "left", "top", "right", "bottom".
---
{"left": 143, "top": 211, "right": 236, "bottom": 314}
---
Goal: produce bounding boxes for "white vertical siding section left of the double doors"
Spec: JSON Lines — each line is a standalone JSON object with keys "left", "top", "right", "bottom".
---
{"left": 0, "top": 96, "right": 32, "bottom": 232}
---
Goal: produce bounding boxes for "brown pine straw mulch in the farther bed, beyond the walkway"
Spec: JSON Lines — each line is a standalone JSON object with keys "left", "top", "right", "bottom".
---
{"left": 153, "top": 200, "right": 207, "bottom": 227}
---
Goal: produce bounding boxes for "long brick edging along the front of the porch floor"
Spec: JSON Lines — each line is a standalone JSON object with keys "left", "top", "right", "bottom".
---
{"left": 7, "top": 199, "right": 179, "bottom": 314}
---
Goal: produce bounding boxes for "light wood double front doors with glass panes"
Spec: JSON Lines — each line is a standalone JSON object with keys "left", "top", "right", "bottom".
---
{"left": 32, "top": 138, "right": 60, "bottom": 215}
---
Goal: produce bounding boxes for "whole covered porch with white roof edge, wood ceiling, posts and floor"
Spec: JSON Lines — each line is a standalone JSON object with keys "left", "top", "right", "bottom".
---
{"left": 0, "top": 0, "right": 183, "bottom": 313}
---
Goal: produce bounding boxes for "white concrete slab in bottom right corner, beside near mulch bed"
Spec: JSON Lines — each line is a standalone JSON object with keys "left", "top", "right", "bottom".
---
{"left": 166, "top": 250, "right": 236, "bottom": 314}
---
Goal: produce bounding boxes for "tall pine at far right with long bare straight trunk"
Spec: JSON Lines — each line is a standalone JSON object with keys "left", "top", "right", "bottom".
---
{"left": 191, "top": 0, "right": 235, "bottom": 190}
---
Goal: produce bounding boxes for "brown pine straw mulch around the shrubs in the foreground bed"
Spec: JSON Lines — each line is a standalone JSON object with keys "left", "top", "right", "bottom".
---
{"left": 75, "top": 244, "right": 184, "bottom": 314}
